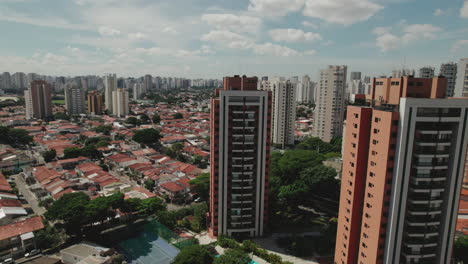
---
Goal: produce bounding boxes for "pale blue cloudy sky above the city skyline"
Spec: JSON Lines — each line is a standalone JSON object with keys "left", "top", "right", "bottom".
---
{"left": 0, "top": 0, "right": 468, "bottom": 80}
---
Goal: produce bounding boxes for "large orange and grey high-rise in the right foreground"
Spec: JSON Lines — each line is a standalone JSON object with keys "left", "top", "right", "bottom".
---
{"left": 335, "top": 77, "right": 468, "bottom": 264}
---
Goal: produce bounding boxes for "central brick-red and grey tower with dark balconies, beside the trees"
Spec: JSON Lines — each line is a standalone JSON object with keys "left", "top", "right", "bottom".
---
{"left": 209, "top": 76, "right": 272, "bottom": 237}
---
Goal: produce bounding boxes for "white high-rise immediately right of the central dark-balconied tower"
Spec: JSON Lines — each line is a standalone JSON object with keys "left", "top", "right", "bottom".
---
{"left": 265, "top": 78, "right": 296, "bottom": 148}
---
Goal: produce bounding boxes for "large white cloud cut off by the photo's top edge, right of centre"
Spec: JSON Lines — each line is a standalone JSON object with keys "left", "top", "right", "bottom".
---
{"left": 303, "top": 0, "right": 383, "bottom": 25}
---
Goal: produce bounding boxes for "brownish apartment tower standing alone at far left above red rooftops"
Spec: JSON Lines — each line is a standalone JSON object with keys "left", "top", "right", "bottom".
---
{"left": 24, "top": 81, "right": 53, "bottom": 120}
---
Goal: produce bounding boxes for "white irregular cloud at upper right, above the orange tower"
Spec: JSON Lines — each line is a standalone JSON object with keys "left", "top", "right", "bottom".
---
{"left": 373, "top": 24, "right": 441, "bottom": 52}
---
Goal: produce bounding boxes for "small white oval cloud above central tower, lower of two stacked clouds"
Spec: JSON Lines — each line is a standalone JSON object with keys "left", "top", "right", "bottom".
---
{"left": 201, "top": 30, "right": 253, "bottom": 49}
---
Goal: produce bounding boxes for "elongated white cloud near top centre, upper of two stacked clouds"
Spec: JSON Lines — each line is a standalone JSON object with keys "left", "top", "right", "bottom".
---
{"left": 201, "top": 14, "right": 262, "bottom": 33}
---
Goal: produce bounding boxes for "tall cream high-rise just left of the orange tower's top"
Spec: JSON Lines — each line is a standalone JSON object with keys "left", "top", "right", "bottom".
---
{"left": 313, "top": 66, "right": 347, "bottom": 142}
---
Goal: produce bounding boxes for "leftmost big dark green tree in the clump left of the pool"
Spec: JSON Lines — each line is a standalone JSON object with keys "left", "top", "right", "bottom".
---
{"left": 45, "top": 192, "right": 90, "bottom": 234}
